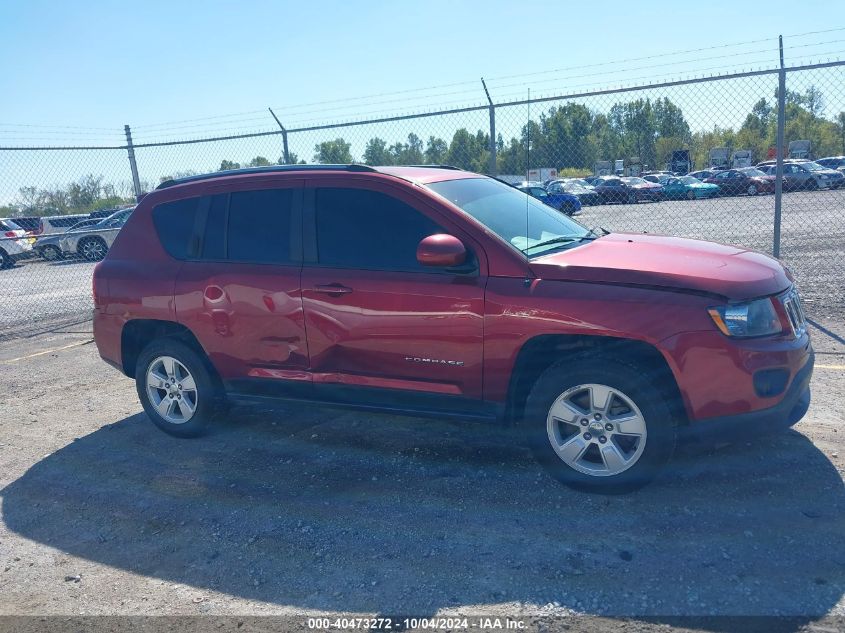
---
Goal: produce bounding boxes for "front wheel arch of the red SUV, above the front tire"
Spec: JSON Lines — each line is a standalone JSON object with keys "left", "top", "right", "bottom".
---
{"left": 505, "top": 334, "right": 689, "bottom": 426}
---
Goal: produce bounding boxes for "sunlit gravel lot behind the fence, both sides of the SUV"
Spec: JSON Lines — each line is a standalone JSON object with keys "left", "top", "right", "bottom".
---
{"left": 0, "top": 189, "right": 845, "bottom": 340}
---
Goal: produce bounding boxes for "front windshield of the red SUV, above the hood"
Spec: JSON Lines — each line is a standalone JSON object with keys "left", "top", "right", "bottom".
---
{"left": 428, "top": 178, "right": 590, "bottom": 257}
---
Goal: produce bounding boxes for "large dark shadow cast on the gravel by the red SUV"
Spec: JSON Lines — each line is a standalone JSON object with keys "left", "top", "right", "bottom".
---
{"left": 2, "top": 409, "right": 845, "bottom": 629}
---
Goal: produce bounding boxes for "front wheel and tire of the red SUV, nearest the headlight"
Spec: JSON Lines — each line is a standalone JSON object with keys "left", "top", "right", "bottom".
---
{"left": 523, "top": 356, "right": 677, "bottom": 494}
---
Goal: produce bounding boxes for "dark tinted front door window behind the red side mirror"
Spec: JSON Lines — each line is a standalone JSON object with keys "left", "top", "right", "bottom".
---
{"left": 315, "top": 189, "right": 443, "bottom": 272}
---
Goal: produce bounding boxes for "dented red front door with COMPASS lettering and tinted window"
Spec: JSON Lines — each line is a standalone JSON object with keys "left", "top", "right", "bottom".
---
{"left": 302, "top": 180, "right": 486, "bottom": 399}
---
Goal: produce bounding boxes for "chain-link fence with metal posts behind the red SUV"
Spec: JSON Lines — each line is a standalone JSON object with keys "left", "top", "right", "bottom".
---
{"left": 0, "top": 62, "right": 845, "bottom": 337}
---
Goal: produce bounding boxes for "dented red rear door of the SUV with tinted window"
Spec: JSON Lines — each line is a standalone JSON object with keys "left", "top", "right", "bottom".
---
{"left": 175, "top": 180, "right": 308, "bottom": 387}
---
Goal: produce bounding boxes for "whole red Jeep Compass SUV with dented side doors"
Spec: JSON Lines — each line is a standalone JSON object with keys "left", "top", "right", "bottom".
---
{"left": 94, "top": 165, "right": 813, "bottom": 492}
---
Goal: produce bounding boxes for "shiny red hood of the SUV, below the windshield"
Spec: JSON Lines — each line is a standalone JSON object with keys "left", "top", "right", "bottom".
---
{"left": 531, "top": 233, "right": 790, "bottom": 300}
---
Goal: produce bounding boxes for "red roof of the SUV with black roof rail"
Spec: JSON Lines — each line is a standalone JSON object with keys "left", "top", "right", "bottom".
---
{"left": 156, "top": 163, "right": 477, "bottom": 189}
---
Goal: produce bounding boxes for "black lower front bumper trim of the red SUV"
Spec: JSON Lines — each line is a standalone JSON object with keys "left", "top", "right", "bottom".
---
{"left": 678, "top": 352, "right": 815, "bottom": 442}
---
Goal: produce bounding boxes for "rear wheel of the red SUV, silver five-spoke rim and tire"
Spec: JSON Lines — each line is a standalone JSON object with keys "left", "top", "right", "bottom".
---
{"left": 135, "top": 339, "right": 223, "bottom": 437}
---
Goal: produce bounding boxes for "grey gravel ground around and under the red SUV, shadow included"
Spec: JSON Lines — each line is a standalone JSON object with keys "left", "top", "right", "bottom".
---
{"left": 0, "top": 319, "right": 845, "bottom": 631}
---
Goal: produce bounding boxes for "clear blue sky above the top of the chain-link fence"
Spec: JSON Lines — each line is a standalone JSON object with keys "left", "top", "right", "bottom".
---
{"left": 0, "top": 0, "right": 845, "bottom": 199}
